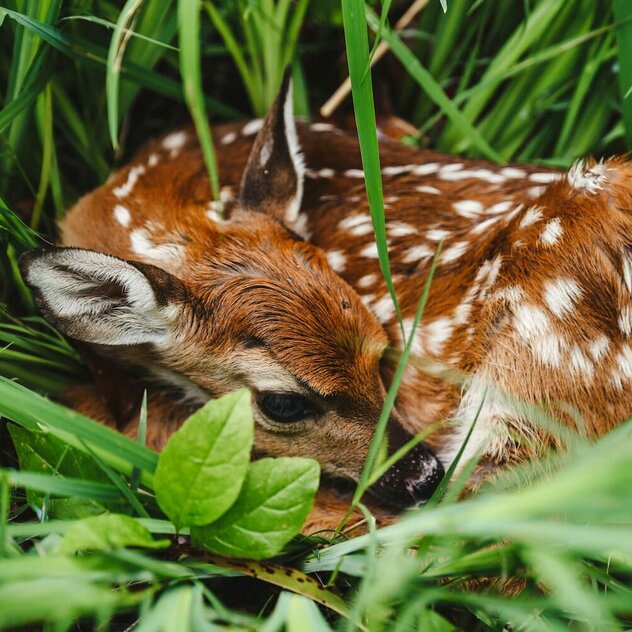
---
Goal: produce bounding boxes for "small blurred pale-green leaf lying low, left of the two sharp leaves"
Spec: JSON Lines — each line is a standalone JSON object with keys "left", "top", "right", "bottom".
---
{"left": 59, "top": 514, "right": 170, "bottom": 555}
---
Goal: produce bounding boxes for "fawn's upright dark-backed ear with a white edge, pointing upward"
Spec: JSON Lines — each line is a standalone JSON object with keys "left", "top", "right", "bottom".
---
{"left": 239, "top": 72, "right": 305, "bottom": 225}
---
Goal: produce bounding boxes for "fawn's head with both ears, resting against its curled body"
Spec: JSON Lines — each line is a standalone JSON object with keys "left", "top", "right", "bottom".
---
{"left": 21, "top": 78, "right": 443, "bottom": 507}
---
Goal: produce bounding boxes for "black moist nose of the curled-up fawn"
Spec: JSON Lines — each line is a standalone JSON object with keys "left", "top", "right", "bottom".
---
{"left": 368, "top": 444, "right": 444, "bottom": 509}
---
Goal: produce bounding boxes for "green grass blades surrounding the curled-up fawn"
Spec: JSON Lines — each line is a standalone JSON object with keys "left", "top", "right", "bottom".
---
{"left": 0, "top": 0, "right": 632, "bottom": 630}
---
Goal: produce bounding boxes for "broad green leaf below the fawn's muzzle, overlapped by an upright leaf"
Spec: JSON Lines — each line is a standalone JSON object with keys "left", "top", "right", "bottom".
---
{"left": 191, "top": 457, "right": 320, "bottom": 559}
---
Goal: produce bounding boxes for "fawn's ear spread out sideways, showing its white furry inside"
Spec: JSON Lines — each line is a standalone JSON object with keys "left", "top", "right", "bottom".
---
{"left": 20, "top": 248, "right": 186, "bottom": 345}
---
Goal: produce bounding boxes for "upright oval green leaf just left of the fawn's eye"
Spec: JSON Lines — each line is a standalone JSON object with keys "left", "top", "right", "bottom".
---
{"left": 154, "top": 389, "right": 254, "bottom": 528}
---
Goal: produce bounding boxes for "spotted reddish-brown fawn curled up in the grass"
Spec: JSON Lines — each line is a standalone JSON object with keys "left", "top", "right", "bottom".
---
{"left": 21, "top": 79, "right": 632, "bottom": 528}
